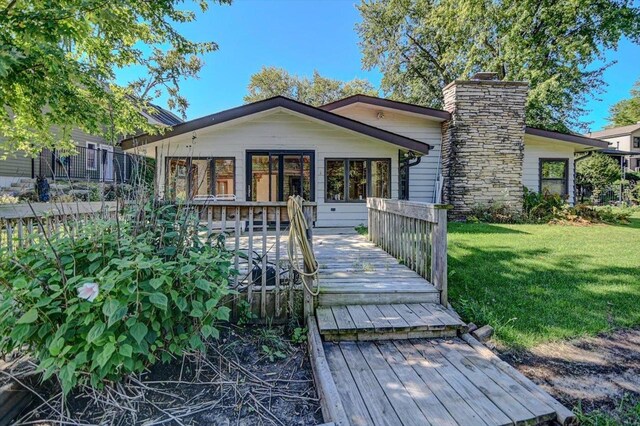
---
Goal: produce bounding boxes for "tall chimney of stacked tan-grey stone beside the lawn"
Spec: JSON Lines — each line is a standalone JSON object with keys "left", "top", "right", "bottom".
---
{"left": 442, "top": 80, "right": 528, "bottom": 218}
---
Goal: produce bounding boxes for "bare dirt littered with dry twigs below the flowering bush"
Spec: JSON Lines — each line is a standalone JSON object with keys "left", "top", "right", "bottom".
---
{"left": 10, "top": 327, "right": 322, "bottom": 425}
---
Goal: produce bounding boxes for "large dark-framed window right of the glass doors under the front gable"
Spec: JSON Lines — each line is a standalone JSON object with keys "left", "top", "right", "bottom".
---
{"left": 325, "top": 158, "right": 391, "bottom": 203}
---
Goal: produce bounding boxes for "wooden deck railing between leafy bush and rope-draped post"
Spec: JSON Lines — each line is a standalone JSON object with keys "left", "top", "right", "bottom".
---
{"left": 190, "top": 200, "right": 317, "bottom": 320}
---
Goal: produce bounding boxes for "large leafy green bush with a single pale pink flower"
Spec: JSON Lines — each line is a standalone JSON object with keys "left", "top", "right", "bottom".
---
{"left": 0, "top": 206, "right": 235, "bottom": 393}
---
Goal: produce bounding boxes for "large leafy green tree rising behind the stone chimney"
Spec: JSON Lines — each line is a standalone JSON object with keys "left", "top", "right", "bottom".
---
{"left": 356, "top": 0, "right": 640, "bottom": 131}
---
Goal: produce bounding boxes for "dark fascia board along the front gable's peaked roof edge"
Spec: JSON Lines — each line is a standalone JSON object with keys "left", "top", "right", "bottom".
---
{"left": 121, "top": 96, "right": 433, "bottom": 154}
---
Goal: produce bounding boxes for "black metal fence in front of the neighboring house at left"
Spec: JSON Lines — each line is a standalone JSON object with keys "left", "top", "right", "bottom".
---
{"left": 32, "top": 147, "right": 137, "bottom": 183}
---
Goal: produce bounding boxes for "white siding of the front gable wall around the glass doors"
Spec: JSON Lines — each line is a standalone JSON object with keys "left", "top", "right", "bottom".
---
{"left": 147, "top": 109, "right": 398, "bottom": 227}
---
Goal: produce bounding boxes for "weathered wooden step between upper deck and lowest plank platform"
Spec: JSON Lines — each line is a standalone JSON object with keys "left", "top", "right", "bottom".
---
{"left": 316, "top": 303, "right": 467, "bottom": 341}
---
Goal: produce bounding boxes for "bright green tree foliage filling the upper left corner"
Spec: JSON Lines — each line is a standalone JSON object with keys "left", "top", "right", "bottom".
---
{"left": 0, "top": 0, "right": 230, "bottom": 154}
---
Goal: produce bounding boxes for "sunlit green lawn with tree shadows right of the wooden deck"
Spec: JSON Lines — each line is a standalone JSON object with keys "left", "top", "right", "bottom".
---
{"left": 449, "top": 213, "right": 640, "bottom": 348}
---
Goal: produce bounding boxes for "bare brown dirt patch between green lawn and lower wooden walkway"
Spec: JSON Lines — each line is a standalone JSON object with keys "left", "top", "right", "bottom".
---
{"left": 501, "top": 329, "right": 640, "bottom": 412}
